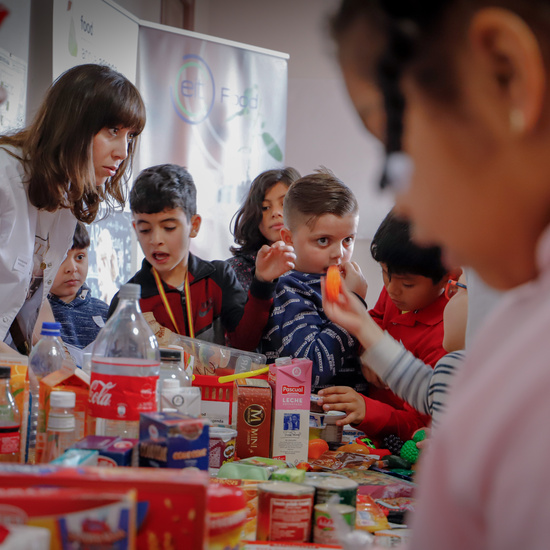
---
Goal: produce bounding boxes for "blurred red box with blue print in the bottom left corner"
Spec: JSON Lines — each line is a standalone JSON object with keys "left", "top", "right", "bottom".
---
{"left": 0, "top": 487, "right": 136, "bottom": 550}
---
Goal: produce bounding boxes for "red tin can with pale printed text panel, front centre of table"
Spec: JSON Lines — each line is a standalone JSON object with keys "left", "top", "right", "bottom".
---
{"left": 256, "top": 481, "right": 315, "bottom": 542}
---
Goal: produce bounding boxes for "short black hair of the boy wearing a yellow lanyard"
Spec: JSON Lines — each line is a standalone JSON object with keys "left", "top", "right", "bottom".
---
{"left": 130, "top": 164, "right": 197, "bottom": 220}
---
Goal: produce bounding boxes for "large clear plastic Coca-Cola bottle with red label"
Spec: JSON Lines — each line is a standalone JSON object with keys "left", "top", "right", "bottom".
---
{"left": 88, "top": 283, "right": 160, "bottom": 439}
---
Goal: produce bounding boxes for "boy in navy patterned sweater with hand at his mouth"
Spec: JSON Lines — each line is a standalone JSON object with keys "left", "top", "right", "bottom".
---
{"left": 260, "top": 168, "right": 367, "bottom": 391}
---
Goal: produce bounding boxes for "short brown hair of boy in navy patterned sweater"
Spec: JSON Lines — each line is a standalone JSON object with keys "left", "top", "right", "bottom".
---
{"left": 283, "top": 167, "right": 359, "bottom": 231}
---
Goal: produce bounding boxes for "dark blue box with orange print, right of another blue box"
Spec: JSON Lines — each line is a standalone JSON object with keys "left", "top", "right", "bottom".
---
{"left": 139, "top": 412, "right": 210, "bottom": 470}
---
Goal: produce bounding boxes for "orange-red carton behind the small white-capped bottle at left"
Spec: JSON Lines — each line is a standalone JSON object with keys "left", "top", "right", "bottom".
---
{"left": 36, "top": 365, "right": 90, "bottom": 462}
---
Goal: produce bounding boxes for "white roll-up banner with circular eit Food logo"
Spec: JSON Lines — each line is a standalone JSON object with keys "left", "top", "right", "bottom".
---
{"left": 137, "top": 25, "right": 288, "bottom": 260}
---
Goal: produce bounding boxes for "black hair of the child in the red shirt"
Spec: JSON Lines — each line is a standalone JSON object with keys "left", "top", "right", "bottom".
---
{"left": 370, "top": 210, "right": 447, "bottom": 284}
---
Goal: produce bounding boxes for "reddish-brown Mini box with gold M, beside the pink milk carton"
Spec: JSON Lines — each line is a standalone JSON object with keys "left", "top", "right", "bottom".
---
{"left": 237, "top": 378, "right": 271, "bottom": 458}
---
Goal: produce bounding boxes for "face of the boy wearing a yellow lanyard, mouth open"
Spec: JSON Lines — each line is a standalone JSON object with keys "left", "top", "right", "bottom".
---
{"left": 132, "top": 207, "right": 200, "bottom": 286}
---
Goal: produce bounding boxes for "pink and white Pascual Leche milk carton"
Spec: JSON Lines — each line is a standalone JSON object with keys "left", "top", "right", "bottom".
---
{"left": 268, "top": 359, "right": 312, "bottom": 465}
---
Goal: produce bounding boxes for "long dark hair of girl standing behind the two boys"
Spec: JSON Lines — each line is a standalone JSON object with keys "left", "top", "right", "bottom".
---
{"left": 229, "top": 166, "right": 300, "bottom": 254}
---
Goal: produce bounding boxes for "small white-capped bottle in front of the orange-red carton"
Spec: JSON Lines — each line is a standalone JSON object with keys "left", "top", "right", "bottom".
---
{"left": 42, "top": 391, "right": 76, "bottom": 462}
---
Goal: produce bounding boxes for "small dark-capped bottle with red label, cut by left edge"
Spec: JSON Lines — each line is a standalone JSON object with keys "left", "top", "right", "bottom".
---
{"left": 0, "top": 366, "right": 21, "bottom": 462}
